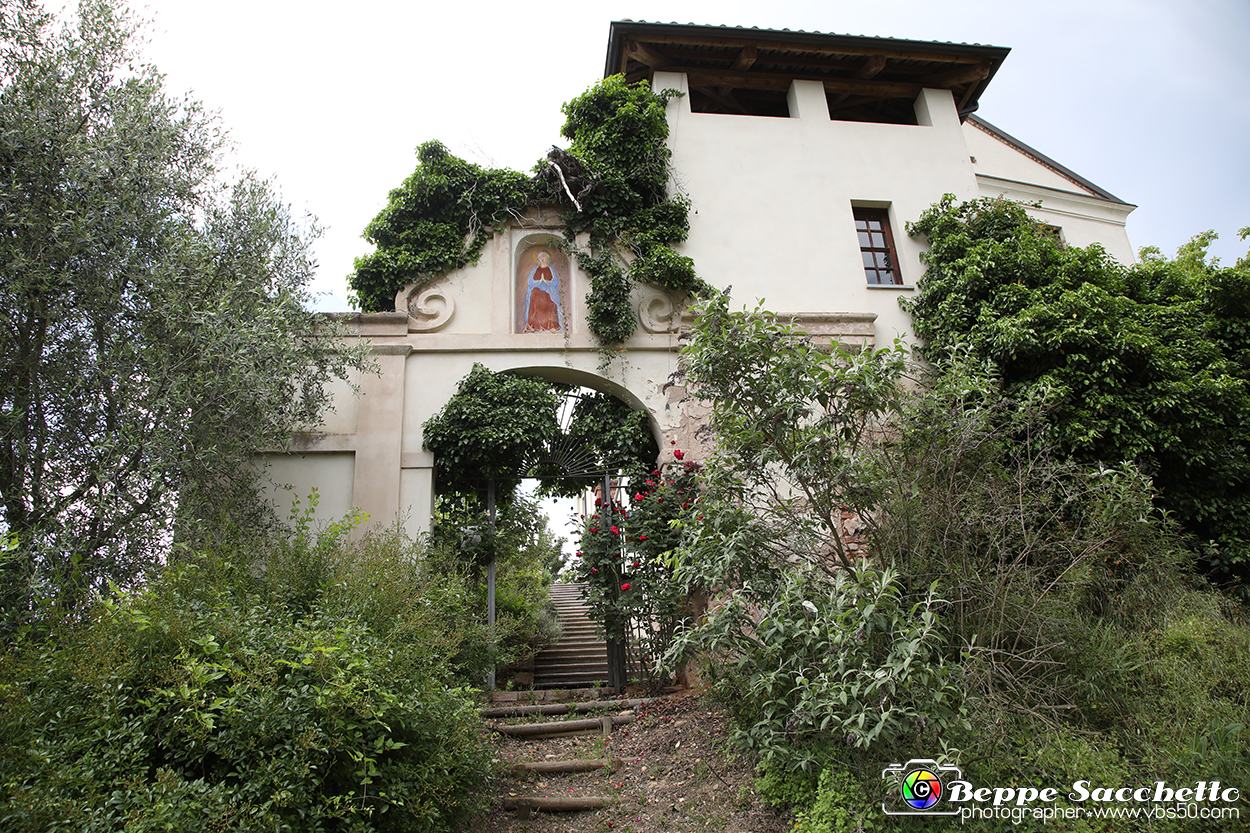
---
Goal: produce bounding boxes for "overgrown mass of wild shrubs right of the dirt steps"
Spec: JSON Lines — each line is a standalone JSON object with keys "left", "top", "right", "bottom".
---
{"left": 674, "top": 300, "right": 1250, "bottom": 830}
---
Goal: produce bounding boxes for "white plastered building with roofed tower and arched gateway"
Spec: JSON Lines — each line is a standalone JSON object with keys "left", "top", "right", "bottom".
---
{"left": 269, "top": 23, "right": 1134, "bottom": 533}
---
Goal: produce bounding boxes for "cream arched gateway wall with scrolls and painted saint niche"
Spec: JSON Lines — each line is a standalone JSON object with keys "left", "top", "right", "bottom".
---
{"left": 257, "top": 211, "right": 875, "bottom": 534}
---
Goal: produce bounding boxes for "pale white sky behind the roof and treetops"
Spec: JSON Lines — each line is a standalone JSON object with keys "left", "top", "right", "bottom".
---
{"left": 100, "top": 0, "right": 1250, "bottom": 310}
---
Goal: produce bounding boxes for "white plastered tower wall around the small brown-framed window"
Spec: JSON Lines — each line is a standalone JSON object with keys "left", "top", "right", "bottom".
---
{"left": 654, "top": 73, "right": 979, "bottom": 344}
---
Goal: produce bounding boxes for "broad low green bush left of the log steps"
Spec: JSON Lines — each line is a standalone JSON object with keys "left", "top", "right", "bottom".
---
{"left": 0, "top": 527, "right": 489, "bottom": 832}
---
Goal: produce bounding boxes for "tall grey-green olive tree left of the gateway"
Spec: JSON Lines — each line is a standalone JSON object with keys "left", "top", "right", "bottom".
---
{"left": 0, "top": 0, "right": 360, "bottom": 624}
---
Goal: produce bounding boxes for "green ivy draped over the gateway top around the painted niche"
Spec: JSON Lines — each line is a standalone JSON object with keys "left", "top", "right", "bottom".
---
{"left": 350, "top": 75, "right": 709, "bottom": 345}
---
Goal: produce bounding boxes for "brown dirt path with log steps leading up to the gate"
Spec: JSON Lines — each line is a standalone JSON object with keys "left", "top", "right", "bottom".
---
{"left": 473, "top": 694, "right": 789, "bottom": 833}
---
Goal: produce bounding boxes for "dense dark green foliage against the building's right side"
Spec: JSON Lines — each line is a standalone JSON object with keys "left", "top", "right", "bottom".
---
{"left": 908, "top": 196, "right": 1250, "bottom": 580}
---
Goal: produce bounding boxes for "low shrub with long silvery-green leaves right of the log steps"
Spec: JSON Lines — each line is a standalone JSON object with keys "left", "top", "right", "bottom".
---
{"left": 675, "top": 564, "right": 965, "bottom": 772}
